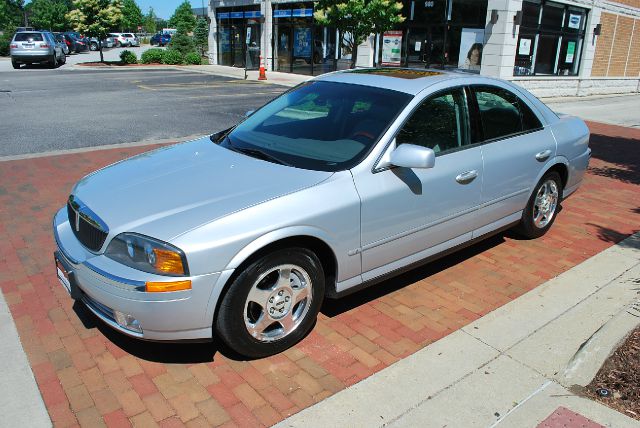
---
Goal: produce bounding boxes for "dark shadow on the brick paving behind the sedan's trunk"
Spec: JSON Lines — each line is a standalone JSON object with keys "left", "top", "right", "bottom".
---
{"left": 589, "top": 134, "right": 640, "bottom": 184}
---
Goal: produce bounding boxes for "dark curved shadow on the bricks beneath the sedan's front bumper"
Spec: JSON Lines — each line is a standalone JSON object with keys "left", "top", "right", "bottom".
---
{"left": 73, "top": 302, "right": 238, "bottom": 364}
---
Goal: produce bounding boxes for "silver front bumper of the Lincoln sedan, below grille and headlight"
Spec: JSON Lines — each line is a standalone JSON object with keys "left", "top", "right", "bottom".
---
{"left": 53, "top": 209, "right": 228, "bottom": 340}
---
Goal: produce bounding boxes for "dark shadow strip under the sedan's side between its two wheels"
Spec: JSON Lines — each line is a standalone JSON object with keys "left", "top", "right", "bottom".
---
{"left": 320, "top": 231, "right": 504, "bottom": 318}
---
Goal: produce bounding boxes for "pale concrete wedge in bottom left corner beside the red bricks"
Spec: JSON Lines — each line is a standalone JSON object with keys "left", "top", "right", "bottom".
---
{"left": 0, "top": 292, "right": 51, "bottom": 428}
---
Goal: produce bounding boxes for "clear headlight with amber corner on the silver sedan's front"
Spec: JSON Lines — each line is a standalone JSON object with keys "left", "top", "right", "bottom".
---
{"left": 104, "top": 233, "right": 189, "bottom": 276}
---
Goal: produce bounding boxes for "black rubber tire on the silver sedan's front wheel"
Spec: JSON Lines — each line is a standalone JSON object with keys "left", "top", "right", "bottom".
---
{"left": 214, "top": 248, "right": 324, "bottom": 358}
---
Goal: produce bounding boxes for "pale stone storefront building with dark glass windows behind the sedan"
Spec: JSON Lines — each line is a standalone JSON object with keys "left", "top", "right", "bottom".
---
{"left": 209, "top": 0, "right": 640, "bottom": 96}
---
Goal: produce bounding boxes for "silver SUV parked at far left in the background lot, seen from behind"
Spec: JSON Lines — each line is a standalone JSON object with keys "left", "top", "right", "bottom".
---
{"left": 10, "top": 31, "right": 67, "bottom": 68}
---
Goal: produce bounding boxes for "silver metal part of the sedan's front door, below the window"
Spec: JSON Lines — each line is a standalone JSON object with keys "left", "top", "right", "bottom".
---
{"left": 355, "top": 147, "right": 482, "bottom": 278}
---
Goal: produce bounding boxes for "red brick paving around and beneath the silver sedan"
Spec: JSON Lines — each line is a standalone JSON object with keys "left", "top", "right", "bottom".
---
{"left": 0, "top": 124, "right": 640, "bottom": 426}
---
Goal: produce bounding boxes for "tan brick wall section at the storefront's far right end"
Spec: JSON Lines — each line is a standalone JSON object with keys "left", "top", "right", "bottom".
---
{"left": 586, "top": 12, "right": 640, "bottom": 77}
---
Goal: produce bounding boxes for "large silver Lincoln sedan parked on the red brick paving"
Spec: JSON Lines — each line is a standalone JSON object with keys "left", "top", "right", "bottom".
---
{"left": 53, "top": 69, "right": 591, "bottom": 357}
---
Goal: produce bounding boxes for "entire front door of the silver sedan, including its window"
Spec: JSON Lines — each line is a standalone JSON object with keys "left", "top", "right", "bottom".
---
{"left": 354, "top": 88, "right": 483, "bottom": 279}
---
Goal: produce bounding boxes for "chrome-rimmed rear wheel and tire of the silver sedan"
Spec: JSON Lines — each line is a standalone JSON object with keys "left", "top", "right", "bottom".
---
{"left": 518, "top": 172, "right": 562, "bottom": 239}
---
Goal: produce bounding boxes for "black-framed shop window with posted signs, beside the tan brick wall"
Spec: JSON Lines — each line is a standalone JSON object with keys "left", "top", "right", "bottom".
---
{"left": 513, "top": 0, "right": 588, "bottom": 76}
